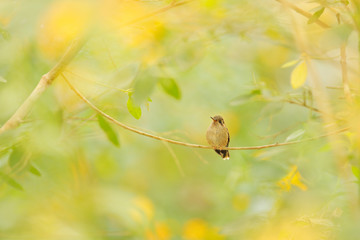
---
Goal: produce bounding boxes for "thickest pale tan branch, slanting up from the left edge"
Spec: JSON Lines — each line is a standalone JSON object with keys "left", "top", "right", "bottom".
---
{"left": 0, "top": 39, "right": 84, "bottom": 134}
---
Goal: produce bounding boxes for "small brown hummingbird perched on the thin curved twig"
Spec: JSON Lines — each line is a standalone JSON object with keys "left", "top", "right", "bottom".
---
{"left": 206, "top": 115, "right": 230, "bottom": 160}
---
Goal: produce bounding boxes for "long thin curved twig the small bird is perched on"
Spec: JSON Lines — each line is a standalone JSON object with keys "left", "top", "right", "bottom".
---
{"left": 61, "top": 74, "right": 350, "bottom": 150}
